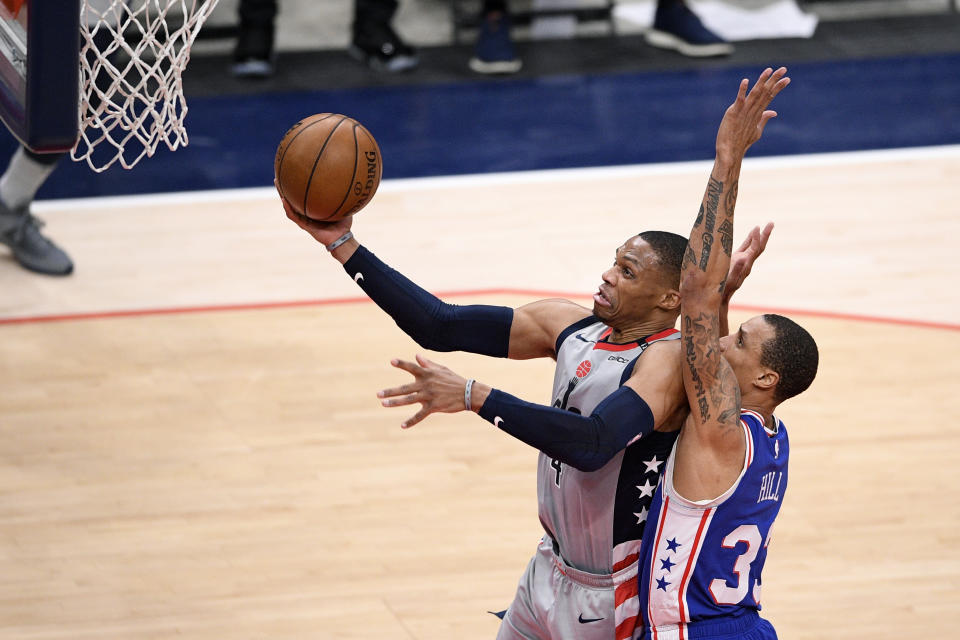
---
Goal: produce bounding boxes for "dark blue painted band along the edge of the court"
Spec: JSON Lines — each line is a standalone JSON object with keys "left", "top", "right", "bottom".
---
{"left": 0, "top": 54, "right": 960, "bottom": 198}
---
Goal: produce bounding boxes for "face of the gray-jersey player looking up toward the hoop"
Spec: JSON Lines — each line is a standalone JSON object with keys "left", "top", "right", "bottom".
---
{"left": 593, "top": 236, "right": 666, "bottom": 327}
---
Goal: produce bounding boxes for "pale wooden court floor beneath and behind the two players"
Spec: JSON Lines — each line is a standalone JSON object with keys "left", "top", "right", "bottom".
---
{"left": 0, "top": 148, "right": 960, "bottom": 640}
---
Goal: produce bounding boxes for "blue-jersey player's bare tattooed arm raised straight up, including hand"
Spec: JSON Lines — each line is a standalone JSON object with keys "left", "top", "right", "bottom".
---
{"left": 674, "top": 67, "right": 790, "bottom": 500}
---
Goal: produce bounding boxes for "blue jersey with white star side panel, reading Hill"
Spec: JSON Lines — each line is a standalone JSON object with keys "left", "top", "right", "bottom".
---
{"left": 639, "top": 410, "right": 790, "bottom": 640}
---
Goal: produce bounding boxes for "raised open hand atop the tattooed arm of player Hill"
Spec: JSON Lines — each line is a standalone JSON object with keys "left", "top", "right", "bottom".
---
{"left": 717, "top": 67, "right": 790, "bottom": 161}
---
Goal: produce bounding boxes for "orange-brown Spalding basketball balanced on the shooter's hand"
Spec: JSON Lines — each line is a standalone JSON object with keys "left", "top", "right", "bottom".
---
{"left": 273, "top": 113, "right": 383, "bottom": 222}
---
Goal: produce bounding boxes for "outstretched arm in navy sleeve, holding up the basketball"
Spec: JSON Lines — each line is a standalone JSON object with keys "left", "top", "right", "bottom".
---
{"left": 281, "top": 192, "right": 589, "bottom": 360}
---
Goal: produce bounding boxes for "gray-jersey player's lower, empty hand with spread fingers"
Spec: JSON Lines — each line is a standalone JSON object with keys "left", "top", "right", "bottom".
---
{"left": 377, "top": 355, "right": 467, "bottom": 429}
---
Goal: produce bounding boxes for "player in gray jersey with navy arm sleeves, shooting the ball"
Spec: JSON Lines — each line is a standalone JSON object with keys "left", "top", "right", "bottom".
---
{"left": 284, "top": 178, "right": 765, "bottom": 640}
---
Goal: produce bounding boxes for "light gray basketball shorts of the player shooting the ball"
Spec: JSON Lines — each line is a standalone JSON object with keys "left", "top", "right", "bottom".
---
{"left": 497, "top": 536, "right": 637, "bottom": 640}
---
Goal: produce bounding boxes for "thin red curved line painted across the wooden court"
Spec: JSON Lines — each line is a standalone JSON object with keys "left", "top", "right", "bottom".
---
{"left": 0, "top": 289, "right": 960, "bottom": 331}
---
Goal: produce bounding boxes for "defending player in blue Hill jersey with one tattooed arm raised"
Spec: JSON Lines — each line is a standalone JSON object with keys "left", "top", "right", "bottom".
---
{"left": 640, "top": 67, "right": 818, "bottom": 640}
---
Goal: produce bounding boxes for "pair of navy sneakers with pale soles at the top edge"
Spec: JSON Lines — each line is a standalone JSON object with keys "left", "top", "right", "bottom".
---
{"left": 470, "top": 0, "right": 733, "bottom": 74}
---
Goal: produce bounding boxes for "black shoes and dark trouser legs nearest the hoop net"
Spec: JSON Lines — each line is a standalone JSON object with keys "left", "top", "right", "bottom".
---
{"left": 232, "top": 0, "right": 419, "bottom": 78}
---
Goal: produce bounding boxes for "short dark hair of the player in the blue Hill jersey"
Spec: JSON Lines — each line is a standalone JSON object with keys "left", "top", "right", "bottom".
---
{"left": 760, "top": 313, "right": 820, "bottom": 404}
